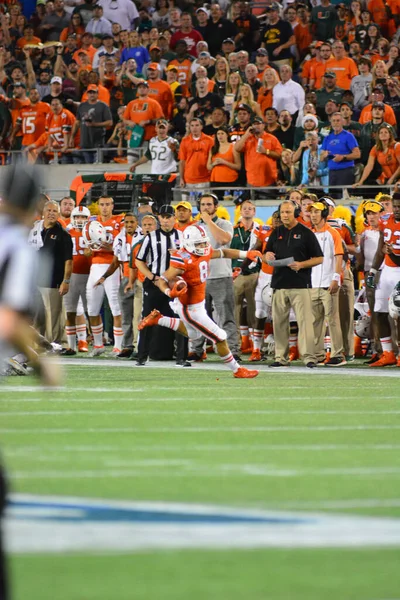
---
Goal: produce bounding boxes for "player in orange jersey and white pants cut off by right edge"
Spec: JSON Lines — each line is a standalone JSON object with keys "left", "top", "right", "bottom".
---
{"left": 366, "top": 194, "right": 400, "bottom": 367}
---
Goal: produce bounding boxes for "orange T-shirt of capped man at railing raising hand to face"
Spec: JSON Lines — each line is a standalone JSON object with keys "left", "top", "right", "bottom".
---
{"left": 244, "top": 132, "right": 283, "bottom": 187}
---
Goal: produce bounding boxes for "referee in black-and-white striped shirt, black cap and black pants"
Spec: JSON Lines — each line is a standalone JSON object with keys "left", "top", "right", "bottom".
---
{"left": 136, "top": 204, "right": 185, "bottom": 366}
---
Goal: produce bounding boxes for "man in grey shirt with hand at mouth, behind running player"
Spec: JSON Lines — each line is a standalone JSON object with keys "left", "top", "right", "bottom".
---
{"left": 192, "top": 192, "right": 239, "bottom": 360}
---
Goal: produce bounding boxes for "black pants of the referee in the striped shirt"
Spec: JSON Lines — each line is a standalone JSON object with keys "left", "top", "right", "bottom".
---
{"left": 138, "top": 279, "right": 188, "bottom": 360}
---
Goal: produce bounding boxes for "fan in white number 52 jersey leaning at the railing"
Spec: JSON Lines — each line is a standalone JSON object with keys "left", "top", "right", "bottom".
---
{"left": 130, "top": 119, "right": 179, "bottom": 175}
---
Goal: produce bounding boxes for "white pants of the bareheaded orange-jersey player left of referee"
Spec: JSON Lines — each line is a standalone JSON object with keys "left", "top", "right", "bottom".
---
{"left": 86, "top": 263, "right": 121, "bottom": 317}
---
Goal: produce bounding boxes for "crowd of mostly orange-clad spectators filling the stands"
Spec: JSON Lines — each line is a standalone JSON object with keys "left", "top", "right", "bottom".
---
{"left": 0, "top": 0, "right": 400, "bottom": 195}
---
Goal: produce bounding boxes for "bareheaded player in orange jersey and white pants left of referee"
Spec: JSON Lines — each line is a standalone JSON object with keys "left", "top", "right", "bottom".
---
{"left": 85, "top": 196, "right": 124, "bottom": 356}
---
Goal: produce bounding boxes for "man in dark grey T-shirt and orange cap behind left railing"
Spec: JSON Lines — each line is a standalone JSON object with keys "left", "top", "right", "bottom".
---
{"left": 71, "top": 84, "right": 113, "bottom": 164}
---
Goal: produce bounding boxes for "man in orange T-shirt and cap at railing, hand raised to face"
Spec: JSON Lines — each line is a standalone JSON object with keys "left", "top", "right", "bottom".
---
{"left": 235, "top": 117, "right": 282, "bottom": 187}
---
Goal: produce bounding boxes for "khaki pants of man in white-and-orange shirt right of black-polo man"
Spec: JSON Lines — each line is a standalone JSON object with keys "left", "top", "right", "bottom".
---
{"left": 311, "top": 288, "right": 343, "bottom": 362}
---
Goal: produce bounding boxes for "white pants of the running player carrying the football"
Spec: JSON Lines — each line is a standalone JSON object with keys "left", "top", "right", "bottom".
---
{"left": 171, "top": 298, "right": 227, "bottom": 344}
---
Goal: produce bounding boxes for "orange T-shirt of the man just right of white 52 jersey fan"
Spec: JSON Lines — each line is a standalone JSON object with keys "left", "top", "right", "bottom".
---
{"left": 179, "top": 133, "right": 214, "bottom": 183}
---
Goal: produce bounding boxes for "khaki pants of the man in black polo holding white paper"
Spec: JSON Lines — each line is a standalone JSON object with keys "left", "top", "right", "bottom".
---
{"left": 272, "top": 289, "right": 317, "bottom": 364}
